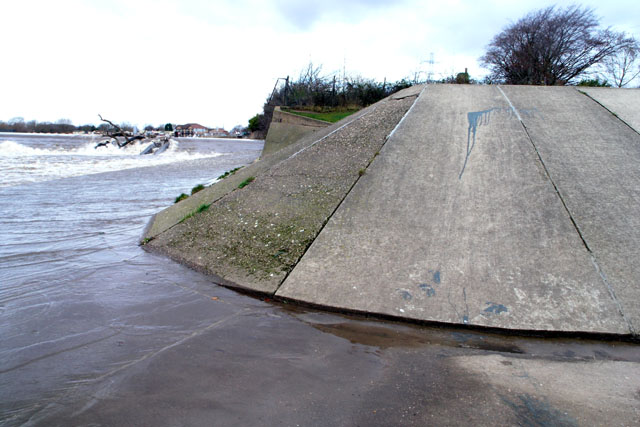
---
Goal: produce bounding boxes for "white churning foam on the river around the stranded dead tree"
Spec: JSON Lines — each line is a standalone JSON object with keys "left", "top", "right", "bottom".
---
{"left": 0, "top": 140, "right": 223, "bottom": 187}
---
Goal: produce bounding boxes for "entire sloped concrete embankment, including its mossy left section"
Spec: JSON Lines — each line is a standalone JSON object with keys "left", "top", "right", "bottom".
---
{"left": 148, "top": 85, "right": 640, "bottom": 336}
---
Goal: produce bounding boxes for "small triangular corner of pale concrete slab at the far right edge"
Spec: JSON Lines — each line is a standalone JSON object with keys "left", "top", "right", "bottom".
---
{"left": 579, "top": 87, "right": 640, "bottom": 136}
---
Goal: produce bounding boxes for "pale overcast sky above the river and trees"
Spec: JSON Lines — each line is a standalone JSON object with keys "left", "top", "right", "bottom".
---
{"left": 0, "top": 0, "right": 640, "bottom": 129}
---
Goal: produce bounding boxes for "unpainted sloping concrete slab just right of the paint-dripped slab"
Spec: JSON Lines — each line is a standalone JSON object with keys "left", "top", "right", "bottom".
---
{"left": 504, "top": 86, "right": 640, "bottom": 334}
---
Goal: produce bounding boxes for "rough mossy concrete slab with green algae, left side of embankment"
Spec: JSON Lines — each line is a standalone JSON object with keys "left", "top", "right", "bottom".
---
{"left": 146, "top": 90, "right": 415, "bottom": 293}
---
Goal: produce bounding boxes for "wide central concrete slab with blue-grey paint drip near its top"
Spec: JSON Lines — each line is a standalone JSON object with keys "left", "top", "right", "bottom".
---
{"left": 277, "top": 85, "right": 640, "bottom": 334}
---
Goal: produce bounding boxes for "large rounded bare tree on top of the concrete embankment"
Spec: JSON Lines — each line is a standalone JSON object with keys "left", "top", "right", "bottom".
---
{"left": 480, "top": 6, "right": 637, "bottom": 85}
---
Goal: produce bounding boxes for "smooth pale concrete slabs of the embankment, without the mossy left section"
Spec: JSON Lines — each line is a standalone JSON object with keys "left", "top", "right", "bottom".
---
{"left": 276, "top": 85, "right": 640, "bottom": 335}
